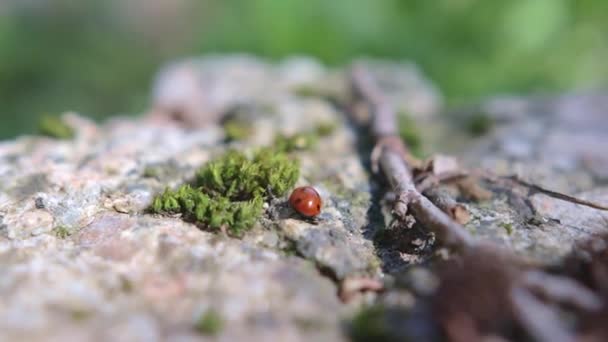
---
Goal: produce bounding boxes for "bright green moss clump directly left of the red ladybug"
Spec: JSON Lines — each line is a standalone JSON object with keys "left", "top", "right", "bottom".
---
{"left": 151, "top": 149, "right": 300, "bottom": 235}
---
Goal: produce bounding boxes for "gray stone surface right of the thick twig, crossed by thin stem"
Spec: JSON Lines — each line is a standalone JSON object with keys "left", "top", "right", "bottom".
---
{"left": 452, "top": 94, "right": 608, "bottom": 262}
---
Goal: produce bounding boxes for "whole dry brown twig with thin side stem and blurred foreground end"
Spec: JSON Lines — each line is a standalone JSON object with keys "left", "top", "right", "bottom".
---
{"left": 347, "top": 67, "right": 608, "bottom": 341}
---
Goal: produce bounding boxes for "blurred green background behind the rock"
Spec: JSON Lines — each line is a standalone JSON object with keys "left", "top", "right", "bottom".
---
{"left": 0, "top": 0, "right": 608, "bottom": 138}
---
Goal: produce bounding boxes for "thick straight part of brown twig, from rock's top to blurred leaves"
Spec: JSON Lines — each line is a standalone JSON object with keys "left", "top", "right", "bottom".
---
{"left": 351, "top": 66, "right": 473, "bottom": 249}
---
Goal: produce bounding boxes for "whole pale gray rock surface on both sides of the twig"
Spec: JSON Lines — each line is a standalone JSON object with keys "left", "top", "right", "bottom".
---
{"left": 0, "top": 56, "right": 608, "bottom": 341}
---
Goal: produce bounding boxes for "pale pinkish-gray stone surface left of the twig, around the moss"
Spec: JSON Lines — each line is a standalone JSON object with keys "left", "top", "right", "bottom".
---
{"left": 0, "top": 57, "right": 404, "bottom": 341}
